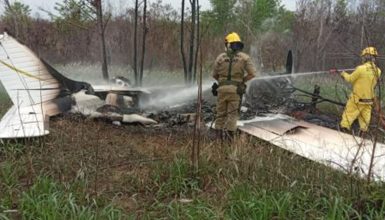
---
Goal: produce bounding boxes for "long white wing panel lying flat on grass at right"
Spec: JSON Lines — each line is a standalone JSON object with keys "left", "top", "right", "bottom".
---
{"left": 239, "top": 117, "right": 385, "bottom": 181}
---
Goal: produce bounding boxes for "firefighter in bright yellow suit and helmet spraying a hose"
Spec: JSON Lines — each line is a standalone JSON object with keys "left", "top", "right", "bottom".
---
{"left": 340, "top": 47, "right": 381, "bottom": 132}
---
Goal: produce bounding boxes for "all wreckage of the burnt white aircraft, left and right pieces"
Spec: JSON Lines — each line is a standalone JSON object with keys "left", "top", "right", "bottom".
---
{"left": 0, "top": 34, "right": 385, "bottom": 181}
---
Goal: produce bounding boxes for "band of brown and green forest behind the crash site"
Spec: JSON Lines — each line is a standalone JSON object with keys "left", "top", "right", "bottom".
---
{"left": 0, "top": 0, "right": 385, "bottom": 84}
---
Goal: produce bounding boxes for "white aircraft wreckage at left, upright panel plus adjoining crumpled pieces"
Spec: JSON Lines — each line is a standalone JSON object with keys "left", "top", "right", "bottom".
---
{"left": 0, "top": 34, "right": 156, "bottom": 138}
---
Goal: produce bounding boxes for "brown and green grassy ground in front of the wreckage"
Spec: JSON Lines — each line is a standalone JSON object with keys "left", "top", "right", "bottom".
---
{"left": 0, "top": 116, "right": 385, "bottom": 219}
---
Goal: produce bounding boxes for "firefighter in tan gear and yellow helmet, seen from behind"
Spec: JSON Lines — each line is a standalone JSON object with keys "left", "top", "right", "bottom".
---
{"left": 212, "top": 32, "right": 256, "bottom": 139}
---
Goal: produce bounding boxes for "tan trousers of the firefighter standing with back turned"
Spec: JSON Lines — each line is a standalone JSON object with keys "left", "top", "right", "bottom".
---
{"left": 215, "top": 92, "right": 240, "bottom": 131}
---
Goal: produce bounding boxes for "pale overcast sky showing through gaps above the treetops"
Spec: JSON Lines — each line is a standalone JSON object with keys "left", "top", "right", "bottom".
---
{"left": 10, "top": 0, "right": 296, "bottom": 17}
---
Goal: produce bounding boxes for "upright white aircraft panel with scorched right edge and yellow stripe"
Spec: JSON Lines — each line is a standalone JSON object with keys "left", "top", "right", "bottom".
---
{"left": 0, "top": 33, "right": 71, "bottom": 138}
